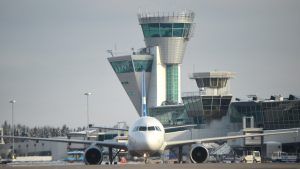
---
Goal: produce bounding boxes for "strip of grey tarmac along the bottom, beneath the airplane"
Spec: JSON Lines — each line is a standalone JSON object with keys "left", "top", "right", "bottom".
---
{"left": 0, "top": 163, "right": 300, "bottom": 169}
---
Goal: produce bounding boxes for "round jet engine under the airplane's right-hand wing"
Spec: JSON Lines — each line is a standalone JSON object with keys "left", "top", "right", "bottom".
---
{"left": 190, "top": 144, "right": 209, "bottom": 163}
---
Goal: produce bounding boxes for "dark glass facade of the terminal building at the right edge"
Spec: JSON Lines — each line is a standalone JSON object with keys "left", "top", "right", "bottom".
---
{"left": 229, "top": 100, "right": 300, "bottom": 130}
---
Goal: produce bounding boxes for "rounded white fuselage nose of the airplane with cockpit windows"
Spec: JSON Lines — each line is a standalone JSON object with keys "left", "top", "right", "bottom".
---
{"left": 128, "top": 116, "right": 165, "bottom": 155}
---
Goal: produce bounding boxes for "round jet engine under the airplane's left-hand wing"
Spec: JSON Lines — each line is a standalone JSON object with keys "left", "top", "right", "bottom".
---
{"left": 84, "top": 146, "right": 103, "bottom": 165}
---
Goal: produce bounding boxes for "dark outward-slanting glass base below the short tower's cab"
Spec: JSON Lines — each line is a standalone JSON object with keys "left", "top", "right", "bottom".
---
{"left": 182, "top": 95, "right": 232, "bottom": 124}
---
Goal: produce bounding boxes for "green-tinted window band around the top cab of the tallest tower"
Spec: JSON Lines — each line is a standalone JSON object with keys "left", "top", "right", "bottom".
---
{"left": 141, "top": 23, "right": 191, "bottom": 37}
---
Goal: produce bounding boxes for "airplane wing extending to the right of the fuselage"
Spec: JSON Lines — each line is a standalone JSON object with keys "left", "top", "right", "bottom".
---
{"left": 165, "top": 130, "right": 298, "bottom": 149}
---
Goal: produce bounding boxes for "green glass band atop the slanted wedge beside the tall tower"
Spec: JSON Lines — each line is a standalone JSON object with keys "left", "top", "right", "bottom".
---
{"left": 110, "top": 60, "right": 153, "bottom": 73}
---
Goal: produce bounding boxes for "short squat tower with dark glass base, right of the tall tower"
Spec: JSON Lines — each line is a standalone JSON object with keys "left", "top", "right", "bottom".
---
{"left": 182, "top": 71, "right": 235, "bottom": 124}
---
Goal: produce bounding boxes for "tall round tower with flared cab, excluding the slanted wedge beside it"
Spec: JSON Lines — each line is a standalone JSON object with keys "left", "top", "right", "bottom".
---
{"left": 138, "top": 11, "right": 194, "bottom": 104}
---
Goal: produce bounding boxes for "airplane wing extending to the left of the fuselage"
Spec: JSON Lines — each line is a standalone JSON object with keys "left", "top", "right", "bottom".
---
{"left": 0, "top": 136, "right": 127, "bottom": 150}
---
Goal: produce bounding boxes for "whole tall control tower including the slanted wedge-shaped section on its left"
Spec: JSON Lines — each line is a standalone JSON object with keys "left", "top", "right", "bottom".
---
{"left": 108, "top": 11, "right": 194, "bottom": 115}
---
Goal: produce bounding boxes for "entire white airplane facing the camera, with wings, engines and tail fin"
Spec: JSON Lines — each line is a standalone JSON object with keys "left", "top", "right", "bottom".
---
{"left": 0, "top": 72, "right": 298, "bottom": 165}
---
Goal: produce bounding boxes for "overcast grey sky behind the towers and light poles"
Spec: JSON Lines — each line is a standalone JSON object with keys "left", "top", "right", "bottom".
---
{"left": 0, "top": 0, "right": 300, "bottom": 127}
